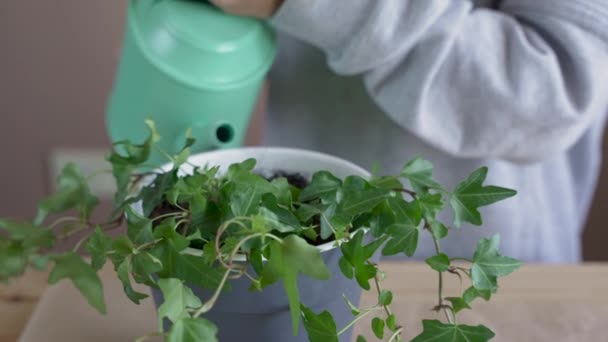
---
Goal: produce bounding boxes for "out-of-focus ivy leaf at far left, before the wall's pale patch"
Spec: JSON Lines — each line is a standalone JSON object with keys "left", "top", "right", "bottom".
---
{"left": 34, "top": 163, "right": 99, "bottom": 225}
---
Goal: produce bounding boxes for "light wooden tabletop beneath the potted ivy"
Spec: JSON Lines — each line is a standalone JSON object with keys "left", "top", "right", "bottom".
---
{"left": 0, "top": 262, "right": 608, "bottom": 342}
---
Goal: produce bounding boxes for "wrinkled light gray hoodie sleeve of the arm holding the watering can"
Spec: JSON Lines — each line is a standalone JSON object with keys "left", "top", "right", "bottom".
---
{"left": 271, "top": 0, "right": 608, "bottom": 162}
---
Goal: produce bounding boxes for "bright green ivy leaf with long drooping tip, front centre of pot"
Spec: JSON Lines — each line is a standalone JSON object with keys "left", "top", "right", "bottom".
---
{"left": 261, "top": 235, "right": 331, "bottom": 336}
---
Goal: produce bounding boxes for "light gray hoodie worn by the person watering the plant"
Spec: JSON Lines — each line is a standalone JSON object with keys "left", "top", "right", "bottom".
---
{"left": 265, "top": 0, "right": 608, "bottom": 263}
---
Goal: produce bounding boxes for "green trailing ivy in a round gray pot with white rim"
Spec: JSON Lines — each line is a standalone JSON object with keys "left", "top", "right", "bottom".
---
{"left": 0, "top": 121, "right": 521, "bottom": 342}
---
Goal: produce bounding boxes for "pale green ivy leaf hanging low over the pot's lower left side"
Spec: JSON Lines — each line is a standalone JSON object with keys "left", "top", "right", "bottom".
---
{"left": 158, "top": 278, "right": 202, "bottom": 326}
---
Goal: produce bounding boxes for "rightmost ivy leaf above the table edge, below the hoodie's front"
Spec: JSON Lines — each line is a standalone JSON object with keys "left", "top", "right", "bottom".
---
{"left": 471, "top": 234, "right": 521, "bottom": 293}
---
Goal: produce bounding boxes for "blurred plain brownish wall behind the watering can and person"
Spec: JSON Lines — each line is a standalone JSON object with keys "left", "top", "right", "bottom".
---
{"left": 0, "top": 0, "right": 608, "bottom": 260}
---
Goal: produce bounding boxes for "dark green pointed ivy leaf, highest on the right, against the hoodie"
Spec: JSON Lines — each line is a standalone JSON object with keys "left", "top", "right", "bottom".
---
{"left": 450, "top": 167, "right": 517, "bottom": 227}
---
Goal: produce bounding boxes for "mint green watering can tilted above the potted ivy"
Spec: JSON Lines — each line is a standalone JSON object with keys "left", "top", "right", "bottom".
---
{"left": 106, "top": 0, "right": 276, "bottom": 164}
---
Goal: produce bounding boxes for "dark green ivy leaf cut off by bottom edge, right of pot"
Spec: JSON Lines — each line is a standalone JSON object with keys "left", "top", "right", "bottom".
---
{"left": 412, "top": 320, "right": 495, "bottom": 342}
